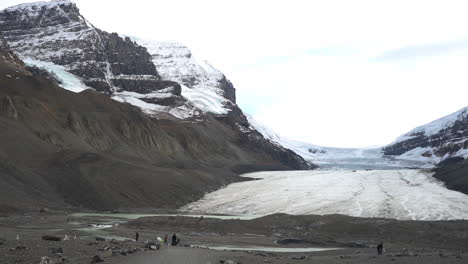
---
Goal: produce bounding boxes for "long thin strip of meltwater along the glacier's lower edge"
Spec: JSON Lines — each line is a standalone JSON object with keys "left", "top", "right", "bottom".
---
{"left": 70, "top": 213, "right": 262, "bottom": 220}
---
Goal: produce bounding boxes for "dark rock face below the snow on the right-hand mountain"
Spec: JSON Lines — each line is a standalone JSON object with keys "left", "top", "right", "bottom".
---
{"left": 383, "top": 108, "right": 468, "bottom": 158}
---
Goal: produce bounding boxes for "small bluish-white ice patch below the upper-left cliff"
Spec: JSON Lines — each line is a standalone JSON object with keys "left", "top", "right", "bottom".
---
{"left": 23, "top": 58, "right": 91, "bottom": 93}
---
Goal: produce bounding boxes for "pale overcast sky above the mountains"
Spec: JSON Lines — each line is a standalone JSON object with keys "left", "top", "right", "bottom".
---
{"left": 0, "top": 0, "right": 468, "bottom": 147}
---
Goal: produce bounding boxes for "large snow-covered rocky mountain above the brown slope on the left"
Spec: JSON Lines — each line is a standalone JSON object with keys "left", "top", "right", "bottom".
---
{"left": 0, "top": 0, "right": 310, "bottom": 168}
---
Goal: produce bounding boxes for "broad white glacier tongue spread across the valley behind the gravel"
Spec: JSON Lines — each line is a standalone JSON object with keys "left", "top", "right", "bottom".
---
{"left": 181, "top": 170, "right": 468, "bottom": 220}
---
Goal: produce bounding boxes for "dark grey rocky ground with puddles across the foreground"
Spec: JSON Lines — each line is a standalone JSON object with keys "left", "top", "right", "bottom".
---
{"left": 0, "top": 212, "right": 468, "bottom": 264}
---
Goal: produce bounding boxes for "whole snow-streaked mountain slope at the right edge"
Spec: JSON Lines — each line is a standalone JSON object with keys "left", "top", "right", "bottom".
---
{"left": 383, "top": 107, "right": 468, "bottom": 164}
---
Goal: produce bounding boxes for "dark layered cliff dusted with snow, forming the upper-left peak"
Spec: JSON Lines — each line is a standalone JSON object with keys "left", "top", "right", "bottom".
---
{"left": 0, "top": 0, "right": 180, "bottom": 96}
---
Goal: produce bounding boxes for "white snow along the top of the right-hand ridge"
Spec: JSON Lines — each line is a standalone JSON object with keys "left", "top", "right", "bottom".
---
{"left": 389, "top": 106, "right": 468, "bottom": 145}
